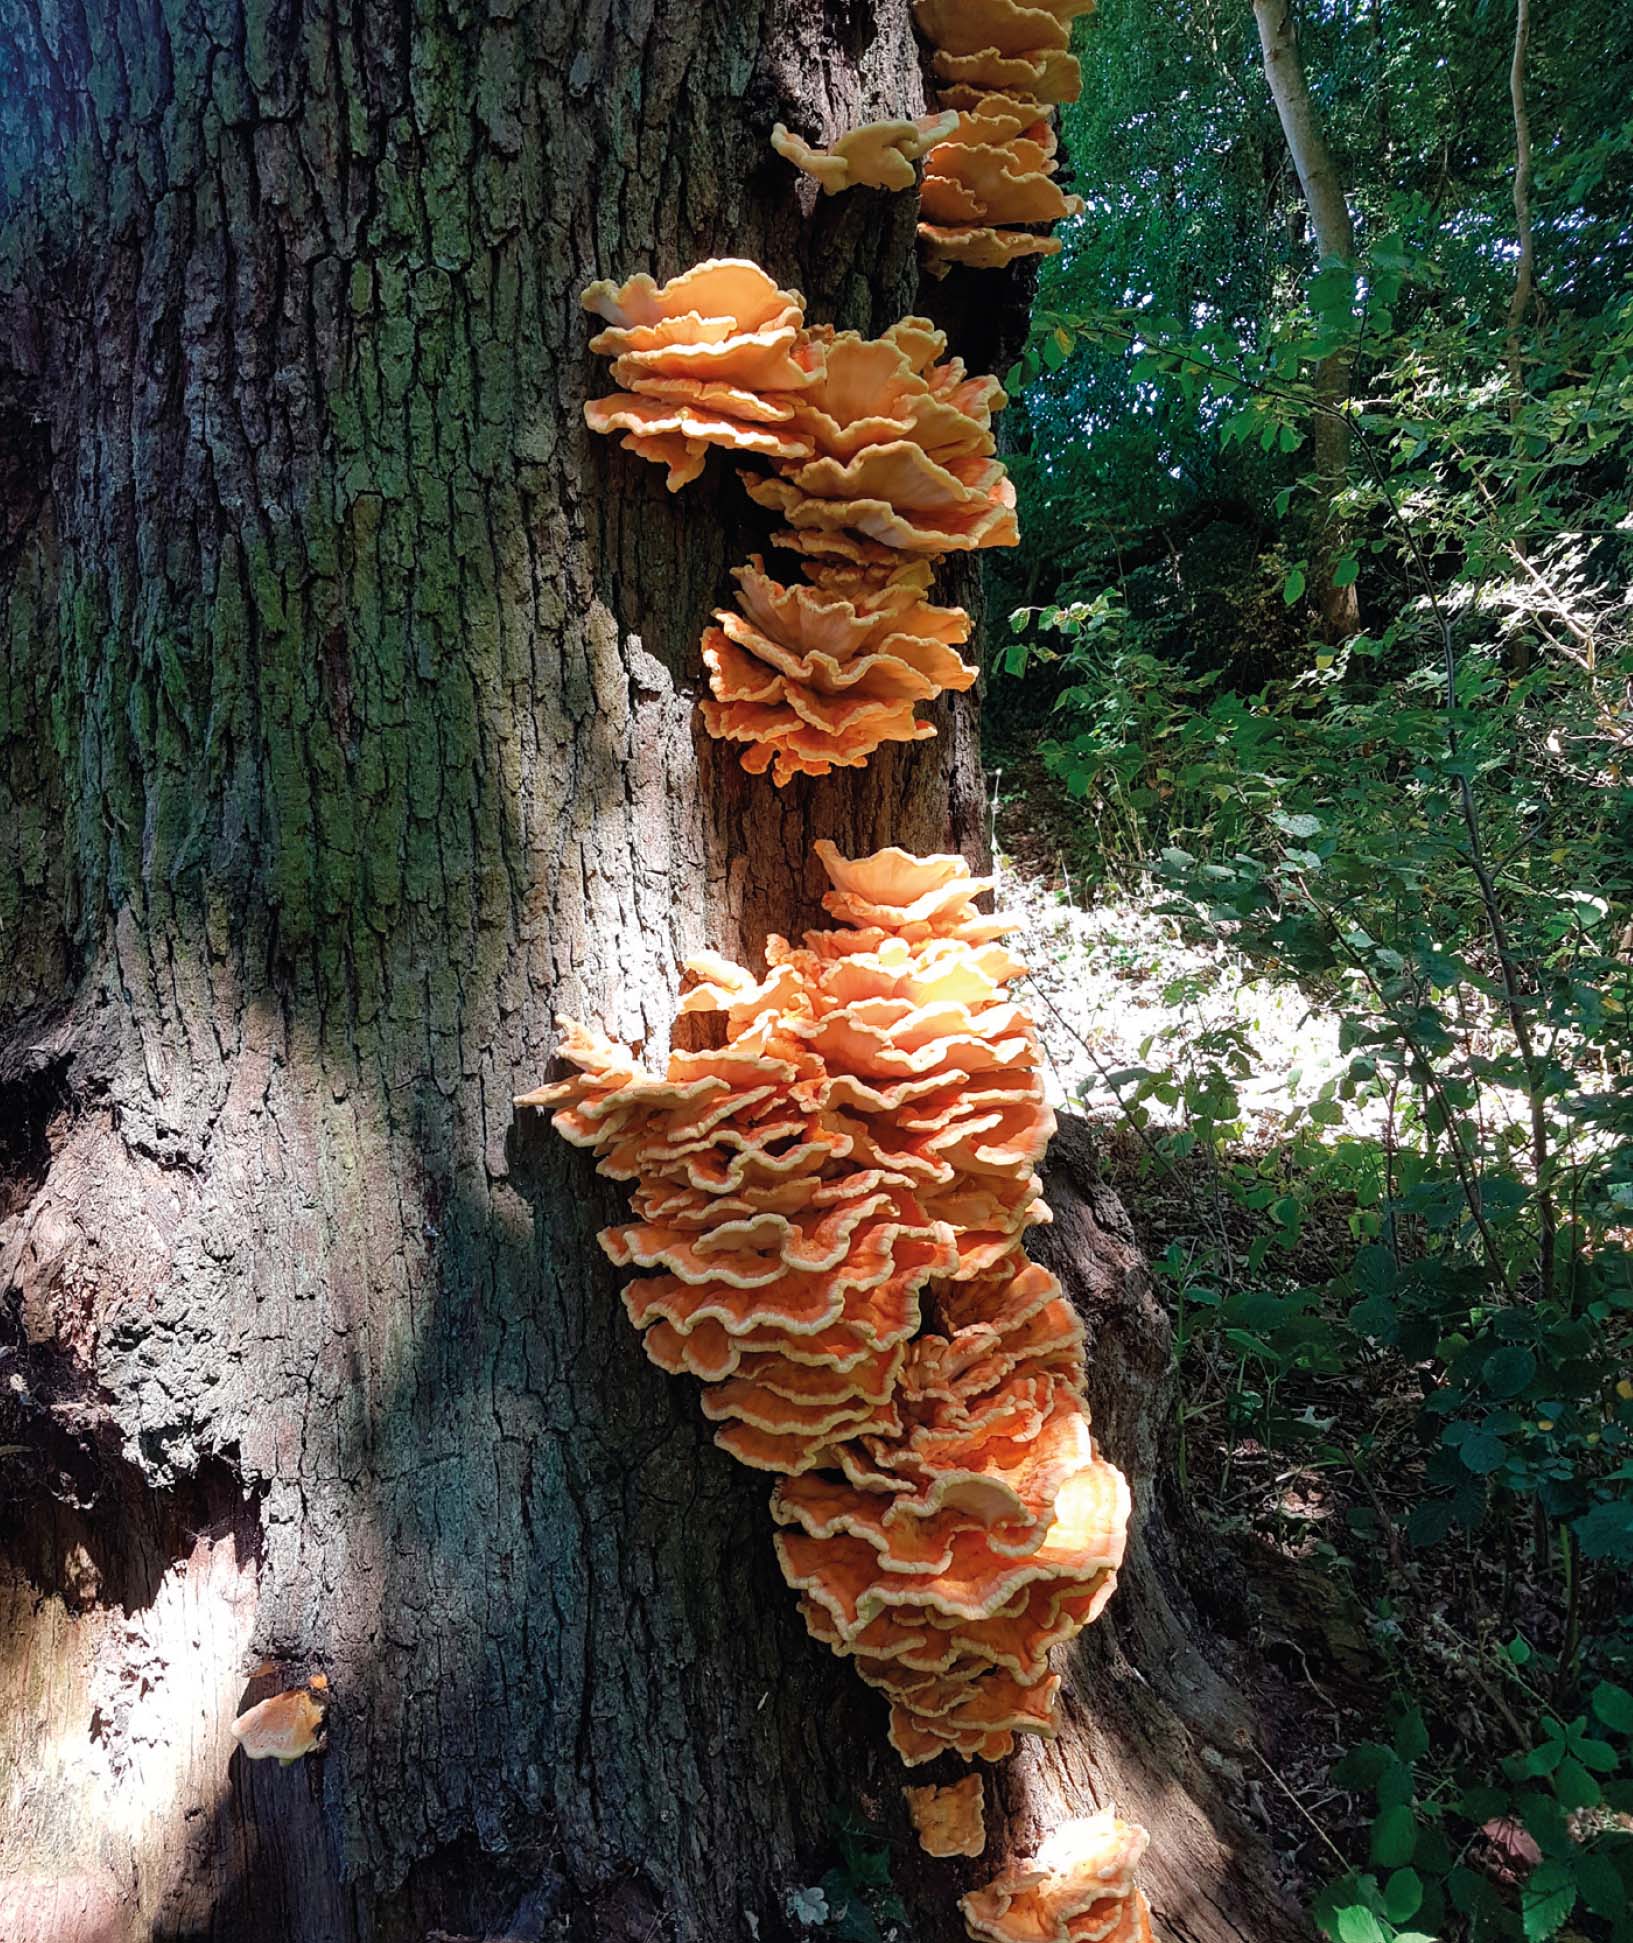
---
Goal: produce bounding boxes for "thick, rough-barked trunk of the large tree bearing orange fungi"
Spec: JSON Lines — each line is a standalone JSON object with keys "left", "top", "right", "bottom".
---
{"left": 0, "top": 0, "right": 1289, "bottom": 1943}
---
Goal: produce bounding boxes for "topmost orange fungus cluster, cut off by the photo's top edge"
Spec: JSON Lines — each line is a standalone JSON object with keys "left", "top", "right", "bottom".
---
{"left": 772, "top": 0, "right": 1094, "bottom": 276}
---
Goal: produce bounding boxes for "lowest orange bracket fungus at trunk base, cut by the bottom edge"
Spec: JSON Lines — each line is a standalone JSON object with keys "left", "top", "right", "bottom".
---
{"left": 958, "top": 1811, "right": 1151, "bottom": 1943}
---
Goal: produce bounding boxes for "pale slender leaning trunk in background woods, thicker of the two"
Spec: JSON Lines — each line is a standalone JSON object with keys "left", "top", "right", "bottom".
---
{"left": 1252, "top": 0, "right": 1359, "bottom": 641}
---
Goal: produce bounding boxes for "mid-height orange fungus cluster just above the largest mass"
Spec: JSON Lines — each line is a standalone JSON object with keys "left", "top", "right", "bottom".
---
{"left": 583, "top": 258, "right": 1019, "bottom": 785}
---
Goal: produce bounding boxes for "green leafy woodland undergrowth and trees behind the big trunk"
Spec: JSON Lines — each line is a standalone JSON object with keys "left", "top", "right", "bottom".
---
{"left": 990, "top": 0, "right": 1633, "bottom": 1943}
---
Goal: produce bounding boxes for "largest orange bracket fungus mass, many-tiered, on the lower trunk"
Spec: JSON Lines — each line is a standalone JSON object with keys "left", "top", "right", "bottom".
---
{"left": 517, "top": 843, "right": 1129, "bottom": 1766}
